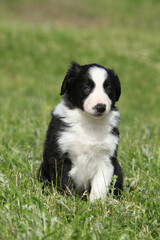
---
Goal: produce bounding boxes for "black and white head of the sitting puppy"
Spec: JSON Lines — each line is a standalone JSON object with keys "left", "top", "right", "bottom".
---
{"left": 61, "top": 62, "right": 121, "bottom": 117}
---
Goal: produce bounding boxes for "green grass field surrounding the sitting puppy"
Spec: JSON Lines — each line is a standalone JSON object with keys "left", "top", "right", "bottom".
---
{"left": 0, "top": 0, "right": 160, "bottom": 240}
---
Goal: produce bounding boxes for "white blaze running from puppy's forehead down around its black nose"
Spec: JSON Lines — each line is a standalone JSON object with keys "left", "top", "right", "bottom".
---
{"left": 84, "top": 66, "right": 111, "bottom": 115}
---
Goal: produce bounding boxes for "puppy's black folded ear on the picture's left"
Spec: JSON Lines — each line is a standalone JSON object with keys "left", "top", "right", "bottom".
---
{"left": 60, "top": 62, "right": 81, "bottom": 95}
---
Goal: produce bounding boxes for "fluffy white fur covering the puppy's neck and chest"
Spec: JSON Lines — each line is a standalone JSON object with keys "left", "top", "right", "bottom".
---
{"left": 54, "top": 103, "right": 119, "bottom": 195}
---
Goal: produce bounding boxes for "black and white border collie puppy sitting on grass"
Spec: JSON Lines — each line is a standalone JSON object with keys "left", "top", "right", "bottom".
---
{"left": 38, "top": 62, "right": 123, "bottom": 202}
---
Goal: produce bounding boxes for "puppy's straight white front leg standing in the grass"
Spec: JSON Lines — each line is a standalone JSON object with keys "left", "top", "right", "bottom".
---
{"left": 90, "top": 164, "right": 113, "bottom": 202}
